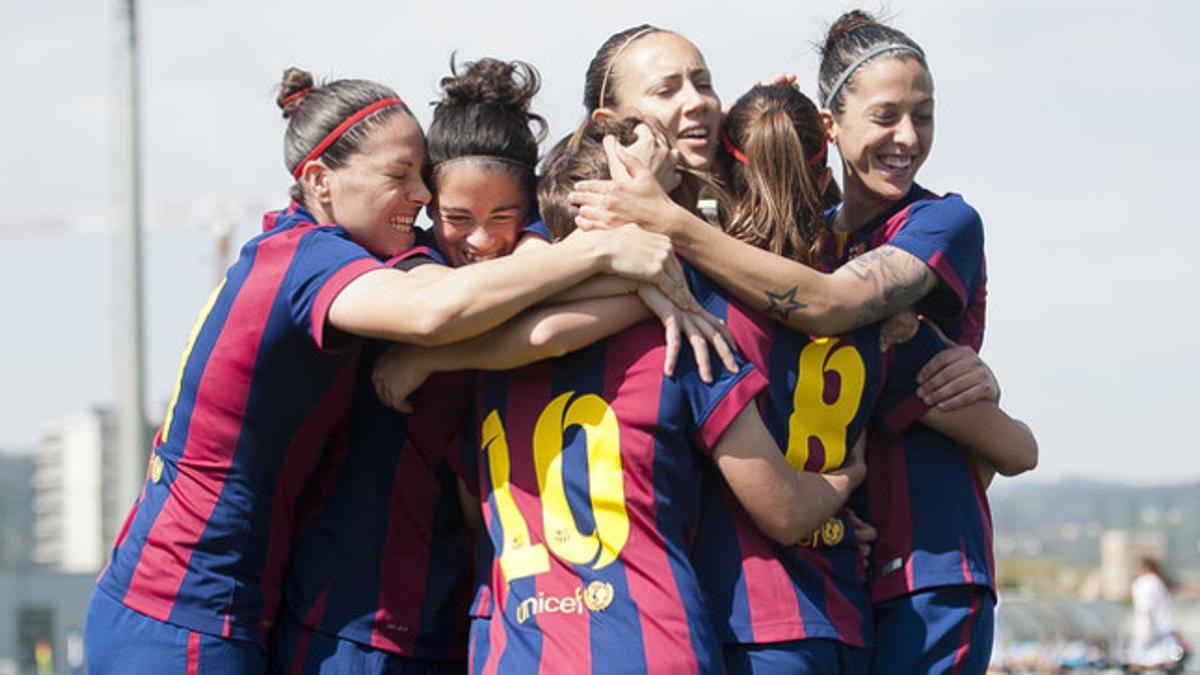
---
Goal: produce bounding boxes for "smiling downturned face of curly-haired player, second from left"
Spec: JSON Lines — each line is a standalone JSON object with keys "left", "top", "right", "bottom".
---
{"left": 430, "top": 161, "right": 530, "bottom": 267}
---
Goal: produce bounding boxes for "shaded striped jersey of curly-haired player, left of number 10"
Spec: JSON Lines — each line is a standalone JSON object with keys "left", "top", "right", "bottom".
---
{"left": 283, "top": 362, "right": 474, "bottom": 661}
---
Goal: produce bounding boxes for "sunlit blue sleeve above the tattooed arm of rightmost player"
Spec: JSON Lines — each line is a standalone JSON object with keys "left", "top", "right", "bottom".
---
{"left": 887, "top": 195, "right": 983, "bottom": 319}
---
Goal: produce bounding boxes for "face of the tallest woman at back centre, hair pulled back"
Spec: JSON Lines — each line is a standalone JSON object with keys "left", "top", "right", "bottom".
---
{"left": 608, "top": 32, "right": 721, "bottom": 172}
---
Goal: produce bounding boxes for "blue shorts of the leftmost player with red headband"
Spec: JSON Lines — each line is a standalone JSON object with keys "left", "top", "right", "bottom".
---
{"left": 83, "top": 589, "right": 266, "bottom": 675}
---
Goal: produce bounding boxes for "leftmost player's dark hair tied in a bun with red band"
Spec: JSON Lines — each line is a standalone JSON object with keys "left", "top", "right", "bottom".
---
{"left": 275, "top": 67, "right": 413, "bottom": 202}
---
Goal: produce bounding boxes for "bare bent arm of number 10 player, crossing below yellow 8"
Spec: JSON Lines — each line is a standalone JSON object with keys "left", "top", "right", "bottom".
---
{"left": 713, "top": 404, "right": 866, "bottom": 545}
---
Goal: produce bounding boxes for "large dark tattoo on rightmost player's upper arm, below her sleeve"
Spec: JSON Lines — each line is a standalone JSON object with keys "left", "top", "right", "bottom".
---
{"left": 846, "top": 246, "right": 937, "bottom": 325}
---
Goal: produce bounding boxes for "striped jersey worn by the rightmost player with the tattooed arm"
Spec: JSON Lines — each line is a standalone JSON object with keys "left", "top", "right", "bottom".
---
{"left": 825, "top": 185, "right": 995, "bottom": 602}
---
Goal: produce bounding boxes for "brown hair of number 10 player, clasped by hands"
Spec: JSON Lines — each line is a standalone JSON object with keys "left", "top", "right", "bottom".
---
{"left": 538, "top": 117, "right": 720, "bottom": 241}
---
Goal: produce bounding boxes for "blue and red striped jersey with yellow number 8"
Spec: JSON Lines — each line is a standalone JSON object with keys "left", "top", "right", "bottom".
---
{"left": 692, "top": 267, "right": 942, "bottom": 646}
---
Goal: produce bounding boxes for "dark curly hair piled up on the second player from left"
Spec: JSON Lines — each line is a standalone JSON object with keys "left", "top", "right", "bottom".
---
{"left": 427, "top": 55, "right": 546, "bottom": 205}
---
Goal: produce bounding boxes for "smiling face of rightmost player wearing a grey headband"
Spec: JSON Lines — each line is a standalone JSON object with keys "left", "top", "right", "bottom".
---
{"left": 824, "top": 58, "right": 934, "bottom": 213}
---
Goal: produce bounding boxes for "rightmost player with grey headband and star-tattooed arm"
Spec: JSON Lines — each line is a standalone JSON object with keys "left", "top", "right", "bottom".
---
{"left": 574, "top": 12, "right": 1032, "bottom": 671}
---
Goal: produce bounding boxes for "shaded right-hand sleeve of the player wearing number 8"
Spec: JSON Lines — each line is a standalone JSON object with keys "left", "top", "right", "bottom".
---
{"left": 871, "top": 324, "right": 947, "bottom": 435}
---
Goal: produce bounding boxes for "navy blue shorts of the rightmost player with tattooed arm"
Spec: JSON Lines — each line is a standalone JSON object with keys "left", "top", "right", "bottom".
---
{"left": 871, "top": 585, "right": 996, "bottom": 675}
